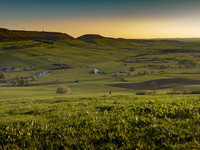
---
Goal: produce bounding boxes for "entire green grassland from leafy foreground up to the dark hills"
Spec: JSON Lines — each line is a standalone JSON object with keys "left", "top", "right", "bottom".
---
{"left": 0, "top": 34, "right": 200, "bottom": 149}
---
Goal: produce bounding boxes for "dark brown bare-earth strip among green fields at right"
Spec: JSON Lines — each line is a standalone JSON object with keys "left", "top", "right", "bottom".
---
{"left": 109, "top": 78, "right": 200, "bottom": 90}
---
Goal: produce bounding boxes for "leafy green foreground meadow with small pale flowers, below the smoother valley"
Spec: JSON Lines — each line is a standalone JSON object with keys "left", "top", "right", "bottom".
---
{"left": 0, "top": 95, "right": 200, "bottom": 149}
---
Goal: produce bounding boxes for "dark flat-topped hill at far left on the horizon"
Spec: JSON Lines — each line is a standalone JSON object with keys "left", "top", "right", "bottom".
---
{"left": 0, "top": 28, "right": 74, "bottom": 41}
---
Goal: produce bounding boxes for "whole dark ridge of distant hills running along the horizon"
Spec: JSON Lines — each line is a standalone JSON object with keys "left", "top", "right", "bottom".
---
{"left": 0, "top": 28, "right": 197, "bottom": 46}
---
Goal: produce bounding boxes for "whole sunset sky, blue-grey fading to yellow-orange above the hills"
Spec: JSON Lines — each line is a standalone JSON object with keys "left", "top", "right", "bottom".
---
{"left": 0, "top": 0, "right": 200, "bottom": 39}
